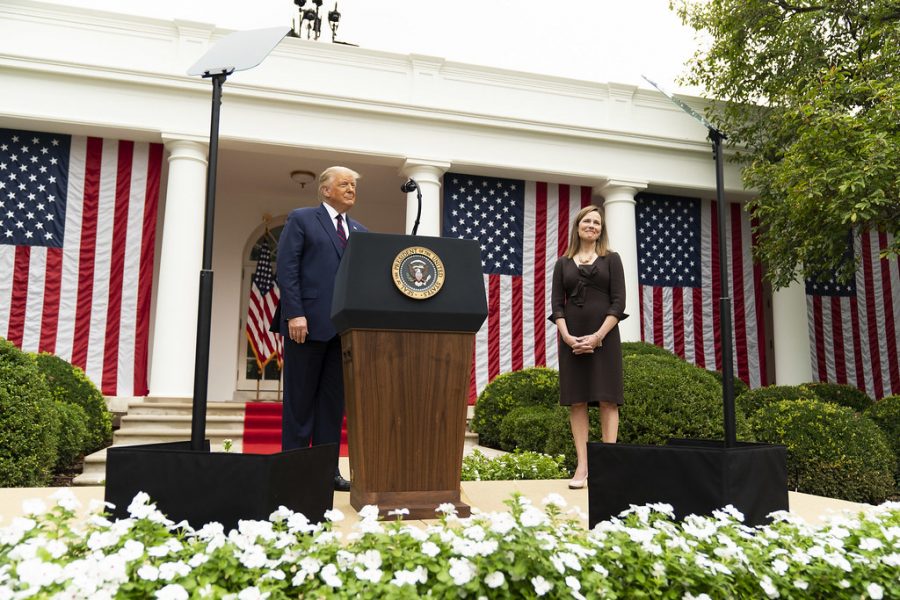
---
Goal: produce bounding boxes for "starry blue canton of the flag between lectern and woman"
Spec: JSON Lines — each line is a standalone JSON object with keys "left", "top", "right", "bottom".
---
{"left": 443, "top": 176, "right": 525, "bottom": 276}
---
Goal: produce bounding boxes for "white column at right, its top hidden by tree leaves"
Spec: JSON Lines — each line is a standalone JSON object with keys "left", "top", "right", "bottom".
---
{"left": 772, "top": 281, "right": 812, "bottom": 385}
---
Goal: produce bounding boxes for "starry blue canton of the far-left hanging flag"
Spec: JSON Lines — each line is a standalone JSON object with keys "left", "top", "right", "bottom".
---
{"left": 0, "top": 129, "right": 70, "bottom": 248}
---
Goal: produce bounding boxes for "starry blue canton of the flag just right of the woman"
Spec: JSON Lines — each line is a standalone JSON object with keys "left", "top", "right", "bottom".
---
{"left": 636, "top": 194, "right": 703, "bottom": 287}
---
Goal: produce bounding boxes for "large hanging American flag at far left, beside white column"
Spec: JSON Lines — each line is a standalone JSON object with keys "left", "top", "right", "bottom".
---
{"left": 0, "top": 129, "right": 163, "bottom": 396}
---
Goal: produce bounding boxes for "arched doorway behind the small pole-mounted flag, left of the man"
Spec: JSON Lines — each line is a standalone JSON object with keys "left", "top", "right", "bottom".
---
{"left": 236, "top": 217, "right": 286, "bottom": 400}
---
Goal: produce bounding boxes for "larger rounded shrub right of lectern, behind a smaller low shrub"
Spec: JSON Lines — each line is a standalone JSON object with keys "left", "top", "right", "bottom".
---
{"left": 470, "top": 367, "right": 559, "bottom": 448}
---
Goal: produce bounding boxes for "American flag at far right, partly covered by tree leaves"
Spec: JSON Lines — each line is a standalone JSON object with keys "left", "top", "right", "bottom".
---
{"left": 806, "top": 232, "right": 900, "bottom": 399}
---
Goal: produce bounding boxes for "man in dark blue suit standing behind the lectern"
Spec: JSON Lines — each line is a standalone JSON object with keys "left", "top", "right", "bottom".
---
{"left": 276, "top": 167, "right": 366, "bottom": 492}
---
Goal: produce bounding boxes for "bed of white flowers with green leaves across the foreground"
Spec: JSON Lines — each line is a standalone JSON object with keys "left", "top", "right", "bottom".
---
{"left": 0, "top": 490, "right": 900, "bottom": 600}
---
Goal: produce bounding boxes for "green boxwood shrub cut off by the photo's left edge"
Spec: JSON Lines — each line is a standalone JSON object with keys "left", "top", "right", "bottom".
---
{"left": 0, "top": 339, "right": 58, "bottom": 487}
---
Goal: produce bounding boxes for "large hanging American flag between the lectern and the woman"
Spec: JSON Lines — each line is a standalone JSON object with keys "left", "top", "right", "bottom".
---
{"left": 442, "top": 173, "right": 591, "bottom": 402}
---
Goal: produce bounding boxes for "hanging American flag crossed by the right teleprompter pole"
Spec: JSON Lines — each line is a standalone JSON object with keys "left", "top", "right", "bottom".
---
{"left": 636, "top": 194, "right": 767, "bottom": 387}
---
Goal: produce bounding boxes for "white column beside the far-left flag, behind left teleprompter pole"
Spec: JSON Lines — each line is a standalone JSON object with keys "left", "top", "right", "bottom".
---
{"left": 150, "top": 136, "right": 207, "bottom": 397}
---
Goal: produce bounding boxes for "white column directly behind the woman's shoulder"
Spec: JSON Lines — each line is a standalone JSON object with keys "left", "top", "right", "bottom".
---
{"left": 595, "top": 179, "right": 647, "bottom": 342}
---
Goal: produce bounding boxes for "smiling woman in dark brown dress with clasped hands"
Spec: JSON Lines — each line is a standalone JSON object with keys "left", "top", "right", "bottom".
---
{"left": 550, "top": 205, "right": 628, "bottom": 489}
